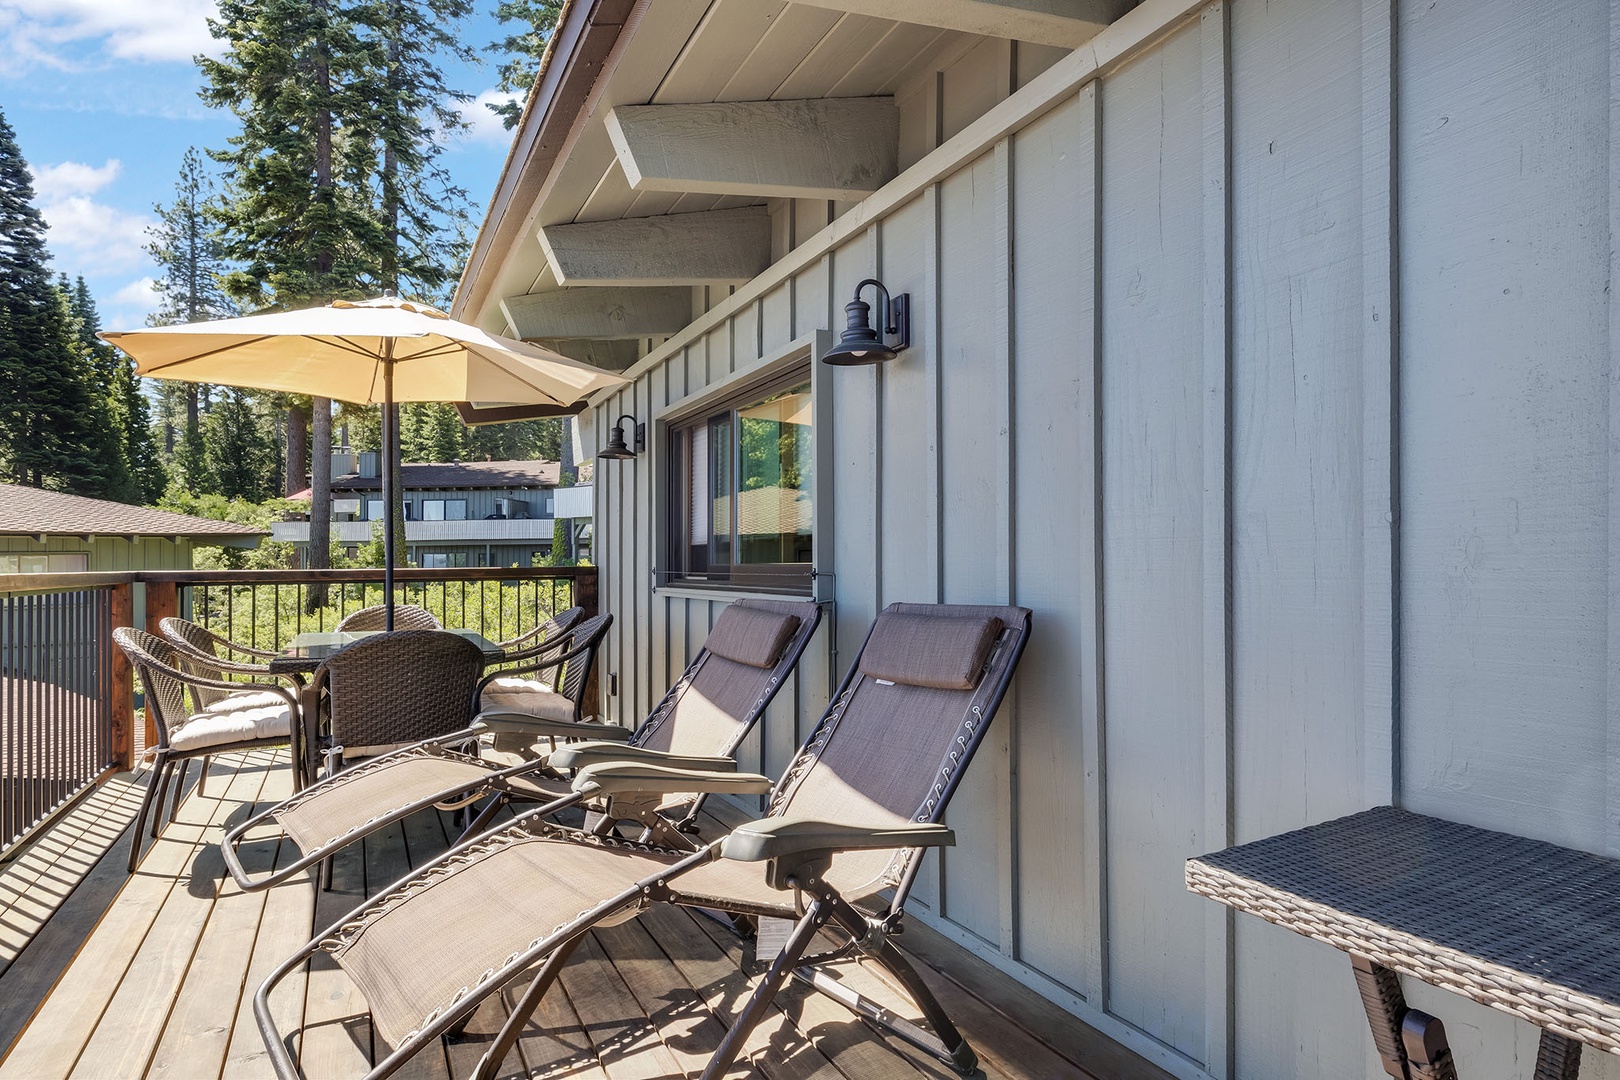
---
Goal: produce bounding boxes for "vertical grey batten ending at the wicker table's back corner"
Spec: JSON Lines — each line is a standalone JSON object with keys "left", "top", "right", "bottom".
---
{"left": 1361, "top": 0, "right": 1401, "bottom": 806}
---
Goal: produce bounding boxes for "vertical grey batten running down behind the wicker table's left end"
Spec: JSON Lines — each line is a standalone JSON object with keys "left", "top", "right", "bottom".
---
{"left": 1200, "top": 3, "right": 1234, "bottom": 1077}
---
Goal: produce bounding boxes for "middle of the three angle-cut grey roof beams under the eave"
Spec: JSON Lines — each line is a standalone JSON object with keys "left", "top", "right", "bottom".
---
{"left": 539, "top": 206, "right": 771, "bottom": 285}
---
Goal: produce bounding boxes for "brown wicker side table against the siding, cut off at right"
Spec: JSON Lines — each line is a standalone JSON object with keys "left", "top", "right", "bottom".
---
{"left": 1186, "top": 806, "right": 1620, "bottom": 1080}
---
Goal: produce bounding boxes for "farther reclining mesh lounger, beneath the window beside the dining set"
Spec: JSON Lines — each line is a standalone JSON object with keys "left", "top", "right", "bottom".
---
{"left": 224, "top": 601, "right": 821, "bottom": 891}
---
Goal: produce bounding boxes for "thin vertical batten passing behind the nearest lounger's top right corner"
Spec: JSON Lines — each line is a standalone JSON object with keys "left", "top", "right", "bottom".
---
{"left": 991, "top": 132, "right": 1019, "bottom": 957}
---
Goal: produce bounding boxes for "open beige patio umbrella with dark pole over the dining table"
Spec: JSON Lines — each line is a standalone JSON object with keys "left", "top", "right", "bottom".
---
{"left": 100, "top": 296, "right": 624, "bottom": 630}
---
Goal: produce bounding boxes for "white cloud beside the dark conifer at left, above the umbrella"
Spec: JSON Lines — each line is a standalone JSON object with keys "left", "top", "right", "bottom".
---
{"left": 32, "top": 159, "right": 152, "bottom": 277}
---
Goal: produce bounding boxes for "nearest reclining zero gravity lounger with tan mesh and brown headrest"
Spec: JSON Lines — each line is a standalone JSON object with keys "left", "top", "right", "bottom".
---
{"left": 253, "top": 604, "right": 1030, "bottom": 1080}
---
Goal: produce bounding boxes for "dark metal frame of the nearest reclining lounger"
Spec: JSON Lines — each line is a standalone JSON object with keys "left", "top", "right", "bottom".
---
{"left": 253, "top": 606, "right": 1030, "bottom": 1080}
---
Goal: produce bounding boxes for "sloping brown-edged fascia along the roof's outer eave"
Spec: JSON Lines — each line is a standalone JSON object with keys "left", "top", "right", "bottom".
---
{"left": 450, "top": 0, "right": 637, "bottom": 319}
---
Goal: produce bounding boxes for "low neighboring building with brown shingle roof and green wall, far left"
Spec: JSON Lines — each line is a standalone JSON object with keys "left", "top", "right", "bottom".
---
{"left": 0, "top": 484, "right": 264, "bottom": 573}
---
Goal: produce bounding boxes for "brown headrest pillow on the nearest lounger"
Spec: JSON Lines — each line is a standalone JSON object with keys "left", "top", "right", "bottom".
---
{"left": 860, "top": 612, "right": 1001, "bottom": 690}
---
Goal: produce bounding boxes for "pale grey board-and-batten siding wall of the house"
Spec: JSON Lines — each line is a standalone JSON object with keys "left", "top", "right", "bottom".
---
{"left": 590, "top": 0, "right": 1620, "bottom": 1080}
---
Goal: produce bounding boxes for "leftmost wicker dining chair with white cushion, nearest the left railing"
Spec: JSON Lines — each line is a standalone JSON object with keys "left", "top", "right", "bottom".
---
{"left": 112, "top": 627, "right": 305, "bottom": 873}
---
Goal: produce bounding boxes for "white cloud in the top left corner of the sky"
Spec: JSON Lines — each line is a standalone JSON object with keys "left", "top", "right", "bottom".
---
{"left": 0, "top": 0, "right": 219, "bottom": 70}
